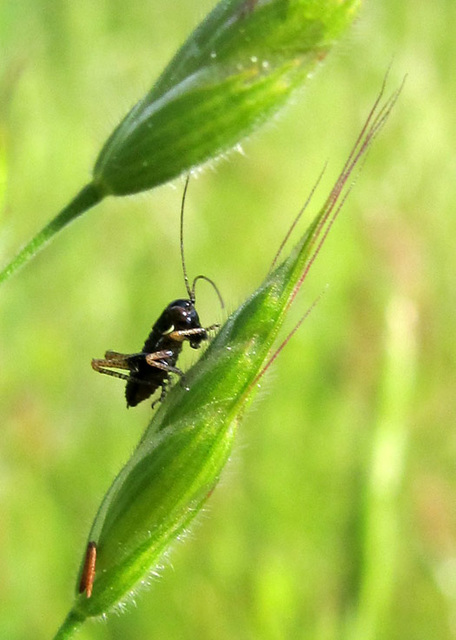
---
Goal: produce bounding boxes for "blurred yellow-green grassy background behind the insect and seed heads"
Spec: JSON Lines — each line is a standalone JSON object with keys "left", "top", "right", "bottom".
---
{"left": 0, "top": 0, "right": 456, "bottom": 640}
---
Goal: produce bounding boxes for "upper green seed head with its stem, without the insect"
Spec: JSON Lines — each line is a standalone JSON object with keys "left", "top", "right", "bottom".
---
{"left": 0, "top": 0, "right": 361, "bottom": 283}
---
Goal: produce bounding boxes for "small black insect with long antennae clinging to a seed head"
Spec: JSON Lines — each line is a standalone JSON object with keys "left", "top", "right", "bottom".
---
{"left": 92, "top": 178, "right": 223, "bottom": 407}
